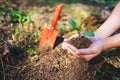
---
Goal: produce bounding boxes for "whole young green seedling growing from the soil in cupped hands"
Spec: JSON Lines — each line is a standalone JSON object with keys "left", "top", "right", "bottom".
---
{"left": 68, "top": 19, "right": 94, "bottom": 37}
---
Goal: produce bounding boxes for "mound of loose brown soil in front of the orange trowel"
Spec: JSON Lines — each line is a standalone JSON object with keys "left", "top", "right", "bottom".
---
{"left": 21, "top": 49, "right": 87, "bottom": 80}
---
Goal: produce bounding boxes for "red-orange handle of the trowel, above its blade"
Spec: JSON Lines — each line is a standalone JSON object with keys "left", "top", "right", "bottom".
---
{"left": 51, "top": 4, "right": 62, "bottom": 30}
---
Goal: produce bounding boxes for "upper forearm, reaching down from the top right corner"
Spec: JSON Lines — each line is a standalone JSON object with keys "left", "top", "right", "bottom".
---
{"left": 95, "top": 2, "right": 120, "bottom": 38}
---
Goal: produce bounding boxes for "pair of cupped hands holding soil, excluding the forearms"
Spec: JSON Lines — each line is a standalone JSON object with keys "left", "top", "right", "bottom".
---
{"left": 62, "top": 34, "right": 103, "bottom": 61}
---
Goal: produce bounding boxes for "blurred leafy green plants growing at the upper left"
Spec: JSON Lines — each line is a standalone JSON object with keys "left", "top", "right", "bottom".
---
{"left": 0, "top": 7, "right": 32, "bottom": 26}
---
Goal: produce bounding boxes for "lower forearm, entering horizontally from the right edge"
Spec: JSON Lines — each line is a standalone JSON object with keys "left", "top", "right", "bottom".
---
{"left": 102, "top": 34, "right": 120, "bottom": 50}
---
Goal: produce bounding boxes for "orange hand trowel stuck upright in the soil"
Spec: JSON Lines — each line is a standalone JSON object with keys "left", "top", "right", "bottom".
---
{"left": 39, "top": 4, "right": 62, "bottom": 48}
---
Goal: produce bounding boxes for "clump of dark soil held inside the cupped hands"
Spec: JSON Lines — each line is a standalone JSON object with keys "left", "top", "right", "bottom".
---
{"left": 69, "top": 36, "right": 92, "bottom": 49}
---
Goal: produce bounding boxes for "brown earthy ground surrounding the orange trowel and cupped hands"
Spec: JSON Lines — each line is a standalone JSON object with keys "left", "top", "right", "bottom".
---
{"left": 0, "top": 0, "right": 120, "bottom": 80}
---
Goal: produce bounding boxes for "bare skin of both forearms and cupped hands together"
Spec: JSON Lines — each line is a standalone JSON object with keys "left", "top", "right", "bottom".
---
{"left": 62, "top": 2, "right": 120, "bottom": 61}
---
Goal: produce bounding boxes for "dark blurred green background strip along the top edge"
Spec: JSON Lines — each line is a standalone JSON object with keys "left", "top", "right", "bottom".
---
{"left": 0, "top": 0, "right": 120, "bottom": 7}
